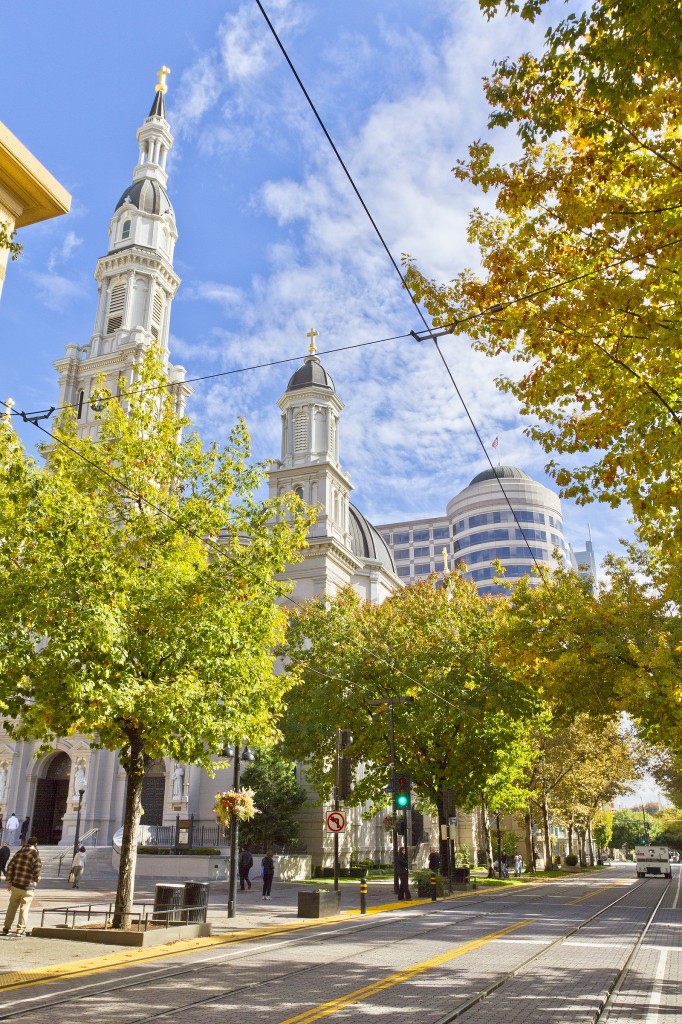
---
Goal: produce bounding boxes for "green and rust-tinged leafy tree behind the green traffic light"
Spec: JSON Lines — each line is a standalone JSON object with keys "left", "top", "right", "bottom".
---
{"left": 282, "top": 571, "right": 538, "bottom": 868}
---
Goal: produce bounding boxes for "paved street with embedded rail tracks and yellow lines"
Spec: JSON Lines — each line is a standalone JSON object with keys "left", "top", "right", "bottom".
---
{"left": 0, "top": 864, "right": 682, "bottom": 1024}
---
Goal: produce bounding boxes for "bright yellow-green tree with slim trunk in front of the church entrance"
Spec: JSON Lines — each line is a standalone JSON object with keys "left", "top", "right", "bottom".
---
{"left": 0, "top": 351, "right": 311, "bottom": 927}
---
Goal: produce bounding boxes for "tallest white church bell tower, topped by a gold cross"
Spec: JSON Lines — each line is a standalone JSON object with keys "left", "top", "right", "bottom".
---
{"left": 54, "top": 67, "right": 191, "bottom": 437}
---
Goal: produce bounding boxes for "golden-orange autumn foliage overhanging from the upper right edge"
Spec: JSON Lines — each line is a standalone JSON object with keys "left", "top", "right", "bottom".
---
{"left": 408, "top": 0, "right": 682, "bottom": 558}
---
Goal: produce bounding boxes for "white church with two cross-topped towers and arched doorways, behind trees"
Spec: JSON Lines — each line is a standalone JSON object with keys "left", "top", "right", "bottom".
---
{"left": 0, "top": 69, "right": 401, "bottom": 861}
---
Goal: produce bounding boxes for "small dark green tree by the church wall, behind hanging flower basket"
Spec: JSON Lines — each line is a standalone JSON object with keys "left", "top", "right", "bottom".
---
{"left": 240, "top": 745, "right": 305, "bottom": 853}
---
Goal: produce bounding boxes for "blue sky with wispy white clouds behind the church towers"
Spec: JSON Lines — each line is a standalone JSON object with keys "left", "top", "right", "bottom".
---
{"left": 0, "top": 0, "right": 629, "bottom": 558}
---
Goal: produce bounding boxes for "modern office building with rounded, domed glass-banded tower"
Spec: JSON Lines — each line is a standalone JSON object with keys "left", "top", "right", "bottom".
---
{"left": 377, "top": 466, "right": 596, "bottom": 594}
